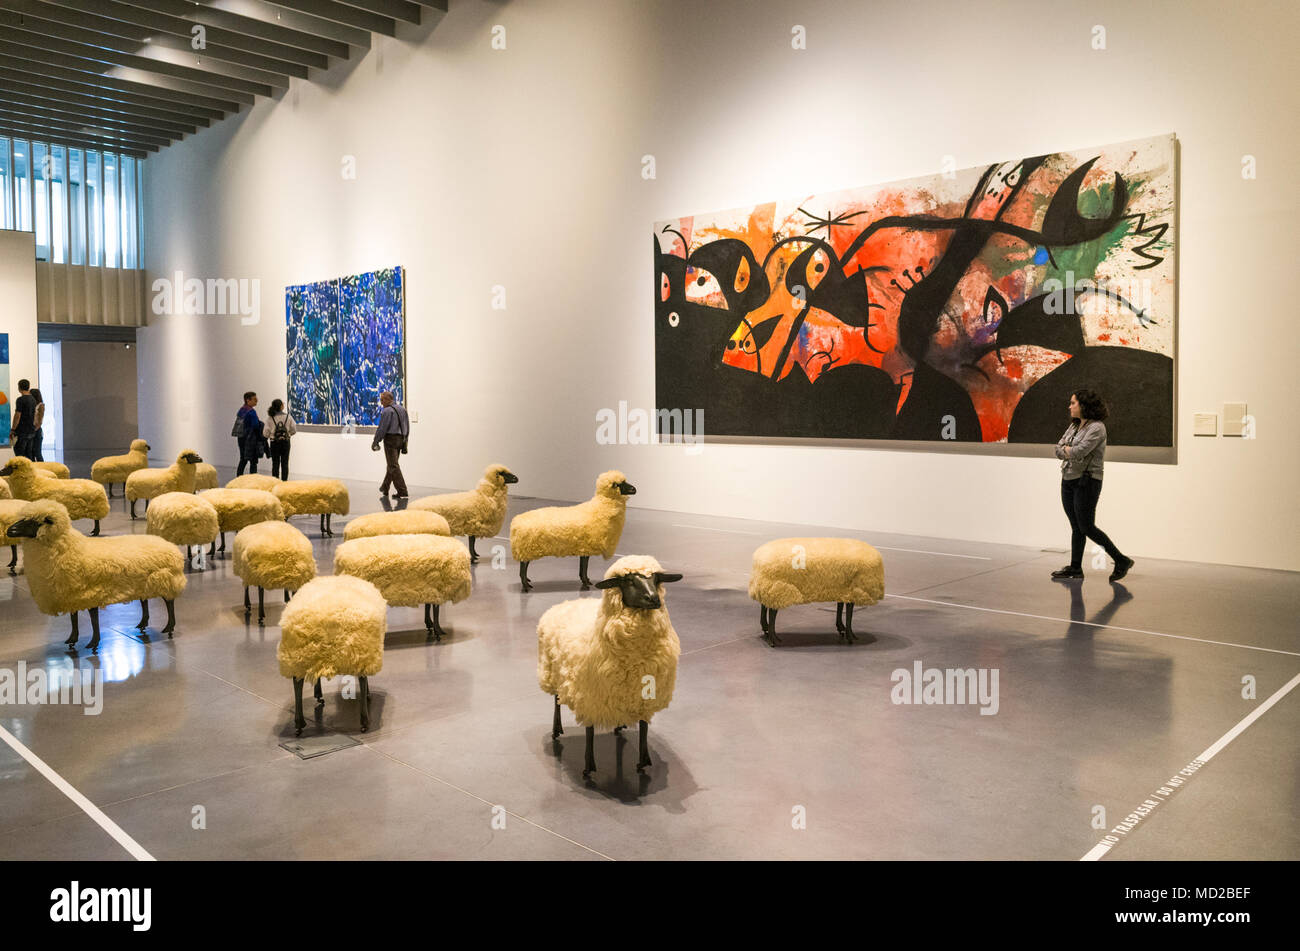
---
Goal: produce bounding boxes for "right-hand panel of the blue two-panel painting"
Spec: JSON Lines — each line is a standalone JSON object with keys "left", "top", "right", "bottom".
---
{"left": 338, "top": 268, "right": 406, "bottom": 426}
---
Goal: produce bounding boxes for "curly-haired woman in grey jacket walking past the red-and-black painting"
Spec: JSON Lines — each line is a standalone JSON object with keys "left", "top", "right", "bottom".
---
{"left": 1052, "top": 390, "right": 1134, "bottom": 581}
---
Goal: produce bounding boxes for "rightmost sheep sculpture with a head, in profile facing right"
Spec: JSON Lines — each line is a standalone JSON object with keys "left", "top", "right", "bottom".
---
{"left": 510, "top": 469, "right": 637, "bottom": 591}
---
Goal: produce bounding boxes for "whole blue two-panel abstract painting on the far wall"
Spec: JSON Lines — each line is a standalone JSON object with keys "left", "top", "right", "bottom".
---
{"left": 285, "top": 268, "right": 406, "bottom": 426}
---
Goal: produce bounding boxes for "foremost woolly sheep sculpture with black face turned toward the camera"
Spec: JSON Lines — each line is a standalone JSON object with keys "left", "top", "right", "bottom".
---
{"left": 537, "top": 555, "right": 681, "bottom": 777}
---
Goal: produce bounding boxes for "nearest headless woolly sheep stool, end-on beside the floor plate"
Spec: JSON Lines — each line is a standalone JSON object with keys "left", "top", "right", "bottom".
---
{"left": 276, "top": 576, "right": 389, "bottom": 735}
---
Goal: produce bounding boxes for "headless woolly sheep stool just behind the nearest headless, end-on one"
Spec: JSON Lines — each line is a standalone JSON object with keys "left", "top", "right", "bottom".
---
{"left": 334, "top": 535, "right": 469, "bottom": 640}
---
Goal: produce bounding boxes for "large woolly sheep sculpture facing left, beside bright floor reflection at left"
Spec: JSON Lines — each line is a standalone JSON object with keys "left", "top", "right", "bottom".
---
{"left": 8, "top": 498, "right": 185, "bottom": 651}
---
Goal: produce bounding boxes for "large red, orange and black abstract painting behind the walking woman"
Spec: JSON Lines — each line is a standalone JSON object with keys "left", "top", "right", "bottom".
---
{"left": 654, "top": 135, "right": 1175, "bottom": 446}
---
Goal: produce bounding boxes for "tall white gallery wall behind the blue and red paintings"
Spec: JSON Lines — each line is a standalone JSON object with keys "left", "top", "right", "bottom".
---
{"left": 138, "top": 0, "right": 1300, "bottom": 570}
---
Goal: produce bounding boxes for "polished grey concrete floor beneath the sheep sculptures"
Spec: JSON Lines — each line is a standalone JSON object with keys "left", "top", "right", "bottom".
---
{"left": 0, "top": 460, "right": 1300, "bottom": 860}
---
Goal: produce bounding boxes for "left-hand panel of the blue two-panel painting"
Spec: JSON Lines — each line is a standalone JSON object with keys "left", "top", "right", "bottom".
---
{"left": 285, "top": 281, "right": 343, "bottom": 425}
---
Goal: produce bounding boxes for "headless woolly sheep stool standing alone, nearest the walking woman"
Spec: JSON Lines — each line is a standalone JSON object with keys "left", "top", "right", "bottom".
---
{"left": 749, "top": 538, "right": 885, "bottom": 646}
